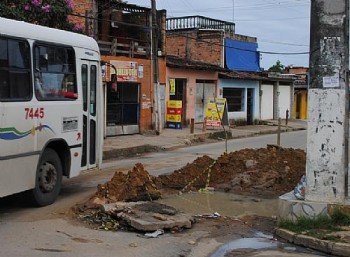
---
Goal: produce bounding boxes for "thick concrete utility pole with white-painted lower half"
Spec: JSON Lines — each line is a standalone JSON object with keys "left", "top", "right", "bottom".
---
{"left": 305, "top": 0, "right": 349, "bottom": 203}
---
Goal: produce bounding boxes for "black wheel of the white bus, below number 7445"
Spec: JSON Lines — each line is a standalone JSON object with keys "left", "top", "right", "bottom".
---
{"left": 31, "top": 148, "right": 62, "bottom": 206}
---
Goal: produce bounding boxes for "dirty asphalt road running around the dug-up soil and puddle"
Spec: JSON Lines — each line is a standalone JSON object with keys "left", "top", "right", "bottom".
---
{"left": 0, "top": 131, "right": 330, "bottom": 257}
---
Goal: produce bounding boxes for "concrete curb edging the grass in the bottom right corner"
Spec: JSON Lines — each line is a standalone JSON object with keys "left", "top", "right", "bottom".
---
{"left": 275, "top": 228, "right": 350, "bottom": 257}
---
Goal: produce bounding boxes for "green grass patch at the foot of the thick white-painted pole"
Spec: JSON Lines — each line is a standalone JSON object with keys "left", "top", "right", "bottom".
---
{"left": 278, "top": 209, "right": 350, "bottom": 241}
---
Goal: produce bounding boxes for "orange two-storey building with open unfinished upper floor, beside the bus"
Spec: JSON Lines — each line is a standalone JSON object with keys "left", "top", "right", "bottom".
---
{"left": 72, "top": 0, "right": 166, "bottom": 136}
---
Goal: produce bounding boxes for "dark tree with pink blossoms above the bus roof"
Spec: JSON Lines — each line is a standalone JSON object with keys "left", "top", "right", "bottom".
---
{"left": 0, "top": 0, "right": 82, "bottom": 32}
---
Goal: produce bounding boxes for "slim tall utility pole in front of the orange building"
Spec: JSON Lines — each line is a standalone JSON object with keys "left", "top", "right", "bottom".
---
{"left": 151, "top": 0, "right": 162, "bottom": 133}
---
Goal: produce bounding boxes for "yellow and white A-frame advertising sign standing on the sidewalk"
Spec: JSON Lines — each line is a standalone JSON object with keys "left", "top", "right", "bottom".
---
{"left": 205, "top": 98, "right": 228, "bottom": 127}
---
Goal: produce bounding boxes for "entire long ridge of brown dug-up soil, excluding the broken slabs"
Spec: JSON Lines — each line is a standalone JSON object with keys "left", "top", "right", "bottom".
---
{"left": 90, "top": 147, "right": 306, "bottom": 205}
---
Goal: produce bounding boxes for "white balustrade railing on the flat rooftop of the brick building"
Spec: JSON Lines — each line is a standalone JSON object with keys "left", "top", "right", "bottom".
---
{"left": 166, "top": 16, "right": 235, "bottom": 35}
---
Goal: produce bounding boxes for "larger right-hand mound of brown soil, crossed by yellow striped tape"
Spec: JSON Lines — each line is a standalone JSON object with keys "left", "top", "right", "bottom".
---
{"left": 157, "top": 147, "right": 306, "bottom": 197}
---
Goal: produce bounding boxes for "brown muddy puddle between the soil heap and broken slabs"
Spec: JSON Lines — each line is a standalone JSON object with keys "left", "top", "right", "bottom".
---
{"left": 159, "top": 192, "right": 278, "bottom": 217}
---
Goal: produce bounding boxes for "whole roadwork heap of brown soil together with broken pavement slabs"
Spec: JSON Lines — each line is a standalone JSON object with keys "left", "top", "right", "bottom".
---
{"left": 76, "top": 146, "right": 306, "bottom": 232}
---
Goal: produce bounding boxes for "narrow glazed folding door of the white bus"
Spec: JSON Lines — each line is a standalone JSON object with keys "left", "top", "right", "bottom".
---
{"left": 81, "top": 61, "right": 100, "bottom": 169}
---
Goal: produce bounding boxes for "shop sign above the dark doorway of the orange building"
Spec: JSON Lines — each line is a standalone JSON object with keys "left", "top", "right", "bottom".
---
{"left": 110, "top": 60, "right": 138, "bottom": 82}
